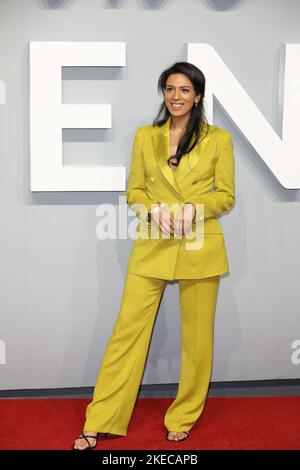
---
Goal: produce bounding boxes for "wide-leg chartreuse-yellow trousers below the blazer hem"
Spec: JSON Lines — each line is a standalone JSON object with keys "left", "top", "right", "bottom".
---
{"left": 83, "top": 272, "right": 219, "bottom": 436}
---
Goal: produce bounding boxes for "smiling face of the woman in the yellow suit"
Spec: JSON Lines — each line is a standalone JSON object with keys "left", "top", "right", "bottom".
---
{"left": 164, "top": 73, "right": 200, "bottom": 117}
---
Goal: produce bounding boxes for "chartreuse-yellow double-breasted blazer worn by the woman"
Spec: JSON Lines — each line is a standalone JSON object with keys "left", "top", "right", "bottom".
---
{"left": 126, "top": 117, "right": 235, "bottom": 280}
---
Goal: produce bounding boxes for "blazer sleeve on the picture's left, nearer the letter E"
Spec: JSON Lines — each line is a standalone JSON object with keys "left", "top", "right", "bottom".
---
{"left": 126, "top": 129, "right": 158, "bottom": 219}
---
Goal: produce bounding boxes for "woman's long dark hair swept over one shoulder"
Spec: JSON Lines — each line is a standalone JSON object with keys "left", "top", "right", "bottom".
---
{"left": 152, "top": 62, "right": 209, "bottom": 165}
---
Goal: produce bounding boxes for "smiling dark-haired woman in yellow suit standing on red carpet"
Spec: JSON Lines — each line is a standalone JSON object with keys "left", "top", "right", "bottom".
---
{"left": 73, "top": 62, "right": 234, "bottom": 450}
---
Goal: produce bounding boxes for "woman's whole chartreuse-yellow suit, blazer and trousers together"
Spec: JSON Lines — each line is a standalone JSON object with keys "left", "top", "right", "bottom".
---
{"left": 84, "top": 118, "right": 234, "bottom": 436}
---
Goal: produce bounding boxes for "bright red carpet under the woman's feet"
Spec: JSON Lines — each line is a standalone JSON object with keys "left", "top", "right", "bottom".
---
{"left": 0, "top": 397, "right": 300, "bottom": 450}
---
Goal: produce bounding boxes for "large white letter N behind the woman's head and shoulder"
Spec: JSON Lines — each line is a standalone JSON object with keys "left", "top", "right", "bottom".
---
{"left": 188, "top": 43, "right": 300, "bottom": 189}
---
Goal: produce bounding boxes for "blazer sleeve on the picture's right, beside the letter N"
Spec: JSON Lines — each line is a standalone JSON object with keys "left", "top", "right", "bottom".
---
{"left": 189, "top": 131, "right": 235, "bottom": 221}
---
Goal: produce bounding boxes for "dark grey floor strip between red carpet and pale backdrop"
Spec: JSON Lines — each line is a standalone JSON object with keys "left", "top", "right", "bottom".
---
{"left": 0, "top": 379, "right": 300, "bottom": 398}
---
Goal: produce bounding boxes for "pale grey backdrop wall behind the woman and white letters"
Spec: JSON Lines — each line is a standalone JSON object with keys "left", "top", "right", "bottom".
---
{"left": 0, "top": 0, "right": 300, "bottom": 390}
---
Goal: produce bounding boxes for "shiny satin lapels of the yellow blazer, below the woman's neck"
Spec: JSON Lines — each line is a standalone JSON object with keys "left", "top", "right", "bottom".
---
{"left": 152, "top": 116, "right": 210, "bottom": 197}
